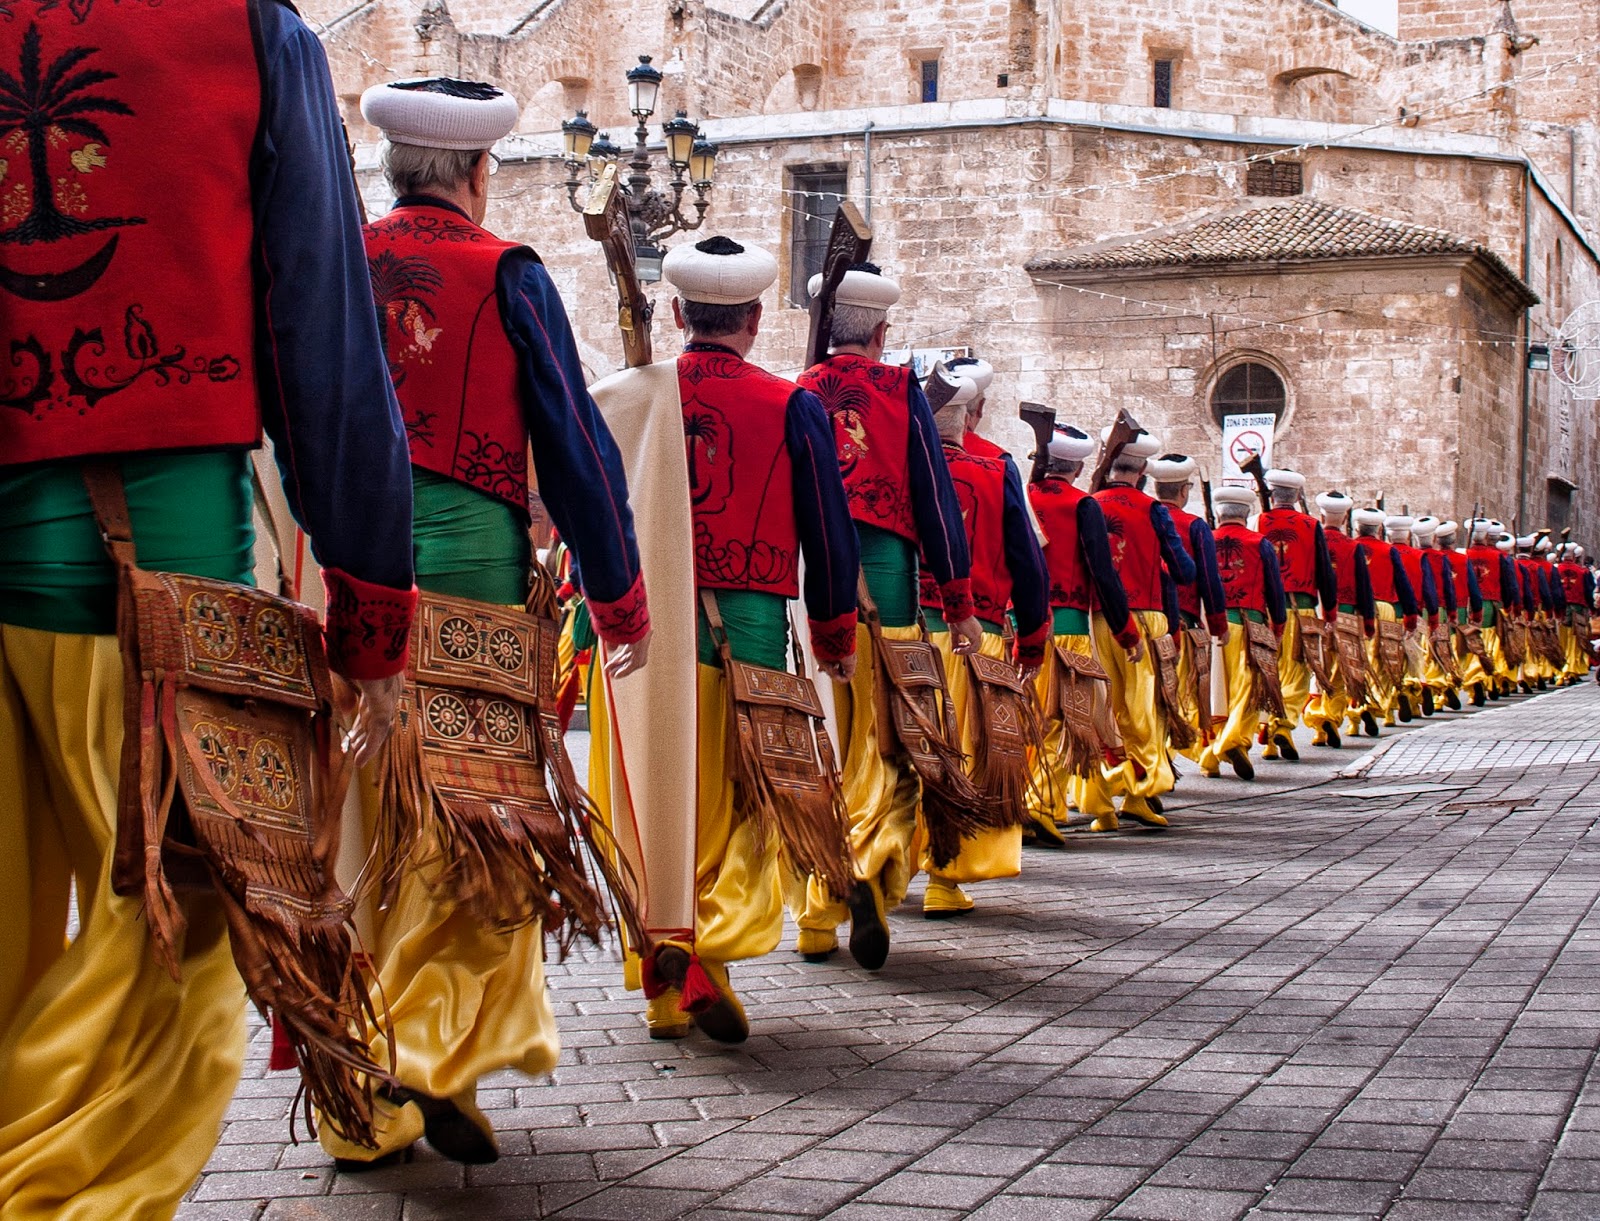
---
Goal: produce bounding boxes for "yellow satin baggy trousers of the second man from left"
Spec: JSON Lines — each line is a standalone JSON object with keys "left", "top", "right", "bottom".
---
{"left": 317, "top": 768, "right": 562, "bottom": 1162}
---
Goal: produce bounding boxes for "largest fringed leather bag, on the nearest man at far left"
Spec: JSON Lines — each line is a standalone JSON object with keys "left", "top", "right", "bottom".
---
{"left": 83, "top": 464, "right": 394, "bottom": 1147}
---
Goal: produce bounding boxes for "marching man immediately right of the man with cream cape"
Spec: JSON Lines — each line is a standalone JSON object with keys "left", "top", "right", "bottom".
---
{"left": 790, "top": 262, "right": 982, "bottom": 970}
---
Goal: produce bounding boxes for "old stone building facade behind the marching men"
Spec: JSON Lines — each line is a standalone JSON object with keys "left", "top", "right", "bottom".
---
{"left": 304, "top": 0, "right": 1600, "bottom": 541}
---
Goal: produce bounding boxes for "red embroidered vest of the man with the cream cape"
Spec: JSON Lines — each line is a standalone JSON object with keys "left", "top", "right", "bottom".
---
{"left": 678, "top": 349, "right": 800, "bottom": 598}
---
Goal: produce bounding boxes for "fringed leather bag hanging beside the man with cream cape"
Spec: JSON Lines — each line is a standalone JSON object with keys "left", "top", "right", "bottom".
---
{"left": 701, "top": 589, "right": 856, "bottom": 901}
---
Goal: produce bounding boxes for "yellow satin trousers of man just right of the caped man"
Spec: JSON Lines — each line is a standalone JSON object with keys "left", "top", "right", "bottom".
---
{"left": 789, "top": 624, "right": 922, "bottom": 930}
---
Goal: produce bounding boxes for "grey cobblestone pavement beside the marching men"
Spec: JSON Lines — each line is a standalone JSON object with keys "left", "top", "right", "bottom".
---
{"left": 179, "top": 683, "right": 1600, "bottom": 1221}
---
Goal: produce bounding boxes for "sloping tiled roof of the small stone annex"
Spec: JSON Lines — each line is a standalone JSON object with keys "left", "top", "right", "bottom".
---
{"left": 1027, "top": 197, "right": 1533, "bottom": 304}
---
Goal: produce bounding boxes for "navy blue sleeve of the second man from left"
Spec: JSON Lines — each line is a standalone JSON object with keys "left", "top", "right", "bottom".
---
{"left": 498, "top": 250, "right": 640, "bottom": 639}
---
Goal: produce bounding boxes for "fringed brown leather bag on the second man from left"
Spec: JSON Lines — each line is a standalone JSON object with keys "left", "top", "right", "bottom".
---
{"left": 371, "top": 565, "right": 648, "bottom": 957}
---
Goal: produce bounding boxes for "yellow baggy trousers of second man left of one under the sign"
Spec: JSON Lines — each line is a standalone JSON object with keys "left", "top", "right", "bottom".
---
{"left": 1074, "top": 611, "right": 1174, "bottom": 818}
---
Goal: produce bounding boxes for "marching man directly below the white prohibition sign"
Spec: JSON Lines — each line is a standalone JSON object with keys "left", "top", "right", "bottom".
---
{"left": 1200, "top": 486, "right": 1286, "bottom": 779}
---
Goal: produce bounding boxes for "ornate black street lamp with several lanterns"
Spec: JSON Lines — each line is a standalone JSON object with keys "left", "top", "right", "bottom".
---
{"left": 562, "top": 54, "right": 717, "bottom": 283}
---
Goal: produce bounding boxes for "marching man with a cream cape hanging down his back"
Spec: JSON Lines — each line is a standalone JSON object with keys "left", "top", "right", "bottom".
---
{"left": 592, "top": 237, "right": 861, "bottom": 1043}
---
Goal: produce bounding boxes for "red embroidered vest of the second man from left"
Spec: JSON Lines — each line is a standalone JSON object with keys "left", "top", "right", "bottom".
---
{"left": 366, "top": 205, "right": 528, "bottom": 512}
